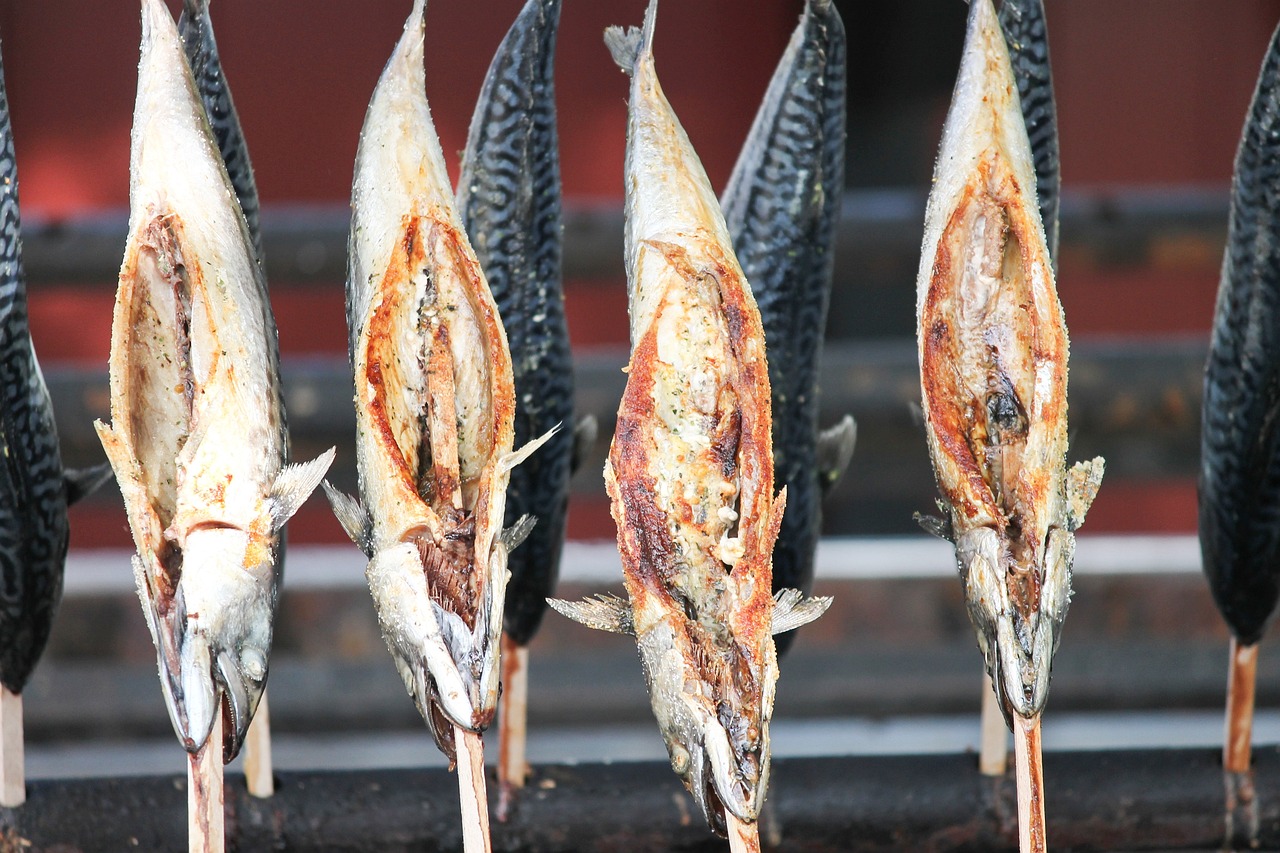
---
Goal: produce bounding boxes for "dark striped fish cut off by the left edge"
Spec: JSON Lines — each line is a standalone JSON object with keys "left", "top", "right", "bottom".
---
{"left": 0, "top": 38, "right": 68, "bottom": 693}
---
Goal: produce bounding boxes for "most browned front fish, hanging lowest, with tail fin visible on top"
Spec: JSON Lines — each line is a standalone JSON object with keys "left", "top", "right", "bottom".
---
{"left": 552, "top": 3, "right": 831, "bottom": 833}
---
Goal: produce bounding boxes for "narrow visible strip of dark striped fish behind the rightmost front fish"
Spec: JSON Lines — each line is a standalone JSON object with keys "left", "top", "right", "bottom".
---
{"left": 1000, "top": 0, "right": 1061, "bottom": 265}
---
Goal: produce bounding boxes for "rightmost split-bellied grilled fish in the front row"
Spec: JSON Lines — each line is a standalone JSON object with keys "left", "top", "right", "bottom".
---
{"left": 918, "top": 0, "right": 1103, "bottom": 721}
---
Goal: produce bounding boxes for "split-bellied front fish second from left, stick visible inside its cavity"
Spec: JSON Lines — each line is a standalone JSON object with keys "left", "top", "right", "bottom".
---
{"left": 325, "top": 0, "right": 545, "bottom": 760}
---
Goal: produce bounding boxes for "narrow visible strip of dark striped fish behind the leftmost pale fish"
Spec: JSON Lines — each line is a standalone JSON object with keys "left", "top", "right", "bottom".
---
{"left": 178, "top": 0, "right": 262, "bottom": 263}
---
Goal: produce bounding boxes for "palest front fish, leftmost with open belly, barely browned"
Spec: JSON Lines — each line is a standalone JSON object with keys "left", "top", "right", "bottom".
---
{"left": 96, "top": 0, "right": 333, "bottom": 761}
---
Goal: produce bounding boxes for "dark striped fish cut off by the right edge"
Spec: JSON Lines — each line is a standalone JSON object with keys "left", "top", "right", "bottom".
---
{"left": 1199, "top": 19, "right": 1280, "bottom": 646}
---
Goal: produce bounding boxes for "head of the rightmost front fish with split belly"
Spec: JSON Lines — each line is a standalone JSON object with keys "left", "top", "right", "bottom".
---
{"left": 956, "top": 526, "right": 1075, "bottom": 724}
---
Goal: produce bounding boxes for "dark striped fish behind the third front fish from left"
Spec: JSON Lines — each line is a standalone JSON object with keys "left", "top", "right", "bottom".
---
{"left": 722, "top": 0, "right": 847, "bottom": 654}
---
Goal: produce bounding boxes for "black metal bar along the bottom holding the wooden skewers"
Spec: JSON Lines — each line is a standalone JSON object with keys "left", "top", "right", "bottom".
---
{"left": 0, "top": 735, "right": 1280, "bottom": 853}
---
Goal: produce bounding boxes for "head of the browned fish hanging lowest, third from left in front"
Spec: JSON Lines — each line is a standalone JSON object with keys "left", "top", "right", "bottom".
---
{"left": 636, "top": 619, "right": 778, "bottom": 834}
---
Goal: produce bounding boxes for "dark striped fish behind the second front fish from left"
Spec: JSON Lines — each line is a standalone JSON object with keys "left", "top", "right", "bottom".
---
{"left": 457, "top": 0, "right": 573, "bottom": 646}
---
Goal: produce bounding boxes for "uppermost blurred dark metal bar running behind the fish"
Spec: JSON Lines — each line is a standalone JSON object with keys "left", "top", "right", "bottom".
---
{"left": 15, "top": 186, "right": 1228, "bottom": 284}
